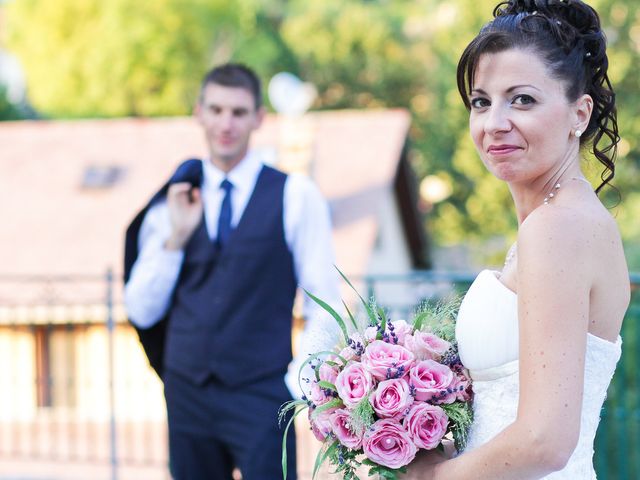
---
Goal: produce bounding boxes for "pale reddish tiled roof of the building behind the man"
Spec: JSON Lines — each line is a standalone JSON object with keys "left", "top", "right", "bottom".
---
{"left": 0, "top": 110, "right": 410, "bottom": 284}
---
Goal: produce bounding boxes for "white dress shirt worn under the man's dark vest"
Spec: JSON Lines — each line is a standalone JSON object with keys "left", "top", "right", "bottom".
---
{"left": 125, "top": 153, "right": 340, "bottom": 397}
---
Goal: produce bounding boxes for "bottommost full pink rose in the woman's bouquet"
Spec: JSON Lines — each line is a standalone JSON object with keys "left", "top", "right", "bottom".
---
{"left": 362, "top": 418, "right": 418, "bottom": 468}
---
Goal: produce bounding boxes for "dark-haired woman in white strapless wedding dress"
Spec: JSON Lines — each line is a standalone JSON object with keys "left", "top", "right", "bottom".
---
{"left": 407, "top": 0, "right": 630, "bottom": 480}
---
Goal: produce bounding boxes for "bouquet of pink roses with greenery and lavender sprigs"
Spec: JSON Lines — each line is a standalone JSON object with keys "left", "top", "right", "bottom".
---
{"left": 280, "top": 272, "right": 472, "bottom": 480}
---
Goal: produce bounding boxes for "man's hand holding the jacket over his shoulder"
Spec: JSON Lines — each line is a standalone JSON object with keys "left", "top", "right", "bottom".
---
{"left": 164, "top": 182, "right": 203, "bottom": 250}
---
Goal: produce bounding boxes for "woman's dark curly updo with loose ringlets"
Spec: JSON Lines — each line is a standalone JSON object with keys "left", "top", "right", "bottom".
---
{"left": 457, "top": 0, "right": 620, "bottom": 193}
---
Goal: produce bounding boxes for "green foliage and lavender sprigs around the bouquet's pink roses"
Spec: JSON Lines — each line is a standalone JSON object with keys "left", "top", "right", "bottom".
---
{"left": 279, "top": 270, "right": 473, "bottom": 480}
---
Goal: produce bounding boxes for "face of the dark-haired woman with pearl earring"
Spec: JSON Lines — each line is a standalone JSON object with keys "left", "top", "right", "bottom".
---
{"left": 469, "top": 49, "right": 584, "bottom": 182}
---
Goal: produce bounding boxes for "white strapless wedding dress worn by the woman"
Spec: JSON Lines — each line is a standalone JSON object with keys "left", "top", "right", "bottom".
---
{"left": 456, "top": 270, "right": 622, "bottom": 480}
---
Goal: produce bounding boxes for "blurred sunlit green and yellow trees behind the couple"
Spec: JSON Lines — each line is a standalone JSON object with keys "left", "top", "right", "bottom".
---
{"left": 6, "top": 0, "right": 640, "bottom": 268}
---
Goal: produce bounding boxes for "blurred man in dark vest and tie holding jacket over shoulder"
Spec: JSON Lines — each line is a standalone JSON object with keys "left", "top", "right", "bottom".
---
{"left": 125, "top": 64, "right": 339, "bottom": 480}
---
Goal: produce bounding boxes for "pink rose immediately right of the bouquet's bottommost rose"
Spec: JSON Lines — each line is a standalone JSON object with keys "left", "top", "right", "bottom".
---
{"left": 403, "top": 402, "right": 449, "bottom": 450}
